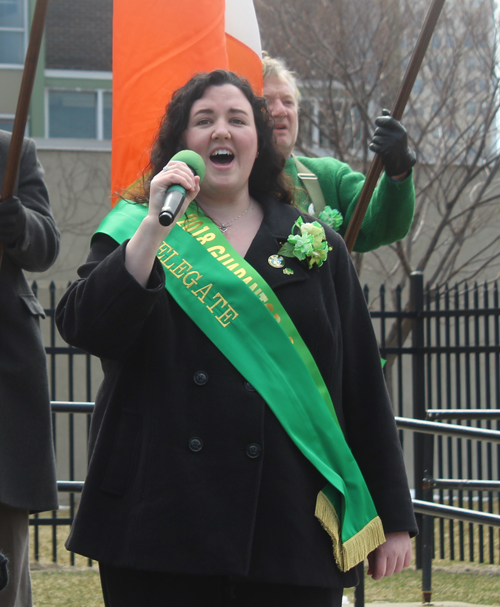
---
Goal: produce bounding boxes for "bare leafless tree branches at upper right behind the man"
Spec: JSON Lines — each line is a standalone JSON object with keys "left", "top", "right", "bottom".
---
{"left": 256, "top": 0, "right": 500, "bottom": 368}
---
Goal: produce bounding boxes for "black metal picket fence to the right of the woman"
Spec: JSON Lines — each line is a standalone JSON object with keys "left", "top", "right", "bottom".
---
{"left": 372, "top": 273, "right": 500, "bottom": 567}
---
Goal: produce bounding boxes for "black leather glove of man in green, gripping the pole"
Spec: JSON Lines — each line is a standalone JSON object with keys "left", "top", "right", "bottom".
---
{"left": 370, "top": 110, "right": 417, "bottom": 177}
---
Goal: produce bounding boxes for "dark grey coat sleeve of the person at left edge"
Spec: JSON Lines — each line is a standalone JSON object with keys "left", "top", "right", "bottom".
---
{"left": 4, "top": 139, "right": 60, "bottom": 272}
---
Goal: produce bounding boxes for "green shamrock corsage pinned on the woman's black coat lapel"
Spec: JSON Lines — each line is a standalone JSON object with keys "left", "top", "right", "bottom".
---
{"left": 278, "top": 217, "right": 332, "bottom": 268}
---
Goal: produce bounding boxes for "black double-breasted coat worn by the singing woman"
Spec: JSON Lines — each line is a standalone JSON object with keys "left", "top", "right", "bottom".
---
{"left": 57, "top": 199, "right": 415, "bottom": 586}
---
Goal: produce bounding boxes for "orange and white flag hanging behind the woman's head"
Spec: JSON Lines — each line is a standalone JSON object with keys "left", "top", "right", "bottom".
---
{"left": 111, "top": 0, "right": 262, "bottom": 204}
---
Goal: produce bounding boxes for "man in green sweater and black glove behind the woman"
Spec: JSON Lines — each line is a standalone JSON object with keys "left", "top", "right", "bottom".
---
{"left": 263, "top": 56, "right": 415, "bottom": 253}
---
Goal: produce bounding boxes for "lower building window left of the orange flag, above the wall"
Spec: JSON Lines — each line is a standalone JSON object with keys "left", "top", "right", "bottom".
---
{"left": 48, "top": 89, "right": 112, "bottom": 140}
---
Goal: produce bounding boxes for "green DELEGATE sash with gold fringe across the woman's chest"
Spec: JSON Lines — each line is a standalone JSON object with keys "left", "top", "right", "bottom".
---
{"left": 96, "top": 201, "right": 385, "bottom": 571}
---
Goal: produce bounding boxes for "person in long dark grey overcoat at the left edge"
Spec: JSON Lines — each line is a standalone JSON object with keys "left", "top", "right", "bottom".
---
{"left": 0, "top": 131, "right": 60, "bottom": 607}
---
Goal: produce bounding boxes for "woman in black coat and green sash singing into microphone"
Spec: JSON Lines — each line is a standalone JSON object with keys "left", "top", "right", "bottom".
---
{"left": 56, "top": 70, "right": 417, "bottom": 607}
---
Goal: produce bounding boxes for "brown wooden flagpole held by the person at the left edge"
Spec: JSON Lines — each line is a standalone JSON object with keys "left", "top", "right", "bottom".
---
{"left": 0, "top": 0, "right": 49, "bottom": 266}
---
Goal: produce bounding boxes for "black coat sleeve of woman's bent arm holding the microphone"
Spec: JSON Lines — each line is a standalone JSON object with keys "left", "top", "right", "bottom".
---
{"left": 56, "top": 234, "right": 165, "bottom": 360}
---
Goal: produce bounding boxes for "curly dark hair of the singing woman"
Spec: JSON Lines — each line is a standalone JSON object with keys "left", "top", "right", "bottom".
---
{"left": 134, "top": 70, "right": 292, "bottom": 204}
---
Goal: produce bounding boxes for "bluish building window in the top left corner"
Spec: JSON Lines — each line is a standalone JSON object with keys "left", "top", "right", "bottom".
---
{"left": 0, "top": 0, "right": 26, "bottom": 65}
